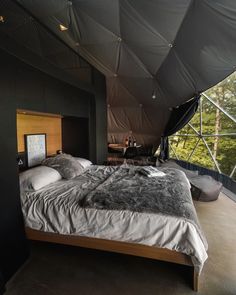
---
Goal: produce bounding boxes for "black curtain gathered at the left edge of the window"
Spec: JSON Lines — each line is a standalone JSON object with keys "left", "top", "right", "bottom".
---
{"left": 159, "top": 94, "right": 201, "bottom": 160}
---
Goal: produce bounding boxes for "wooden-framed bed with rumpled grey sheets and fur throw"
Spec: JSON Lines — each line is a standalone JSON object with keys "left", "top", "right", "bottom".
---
{"left": 21, "top": 156, "right": 207, "bottom": 291}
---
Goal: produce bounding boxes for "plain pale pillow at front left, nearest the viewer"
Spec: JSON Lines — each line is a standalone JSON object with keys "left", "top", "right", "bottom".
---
{"left": 20, "top": 166, "right": 62, "bottom": 191}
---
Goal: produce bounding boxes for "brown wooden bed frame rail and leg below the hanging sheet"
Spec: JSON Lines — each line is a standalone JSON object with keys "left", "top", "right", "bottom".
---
{"left": 25, "top": 228, "right": 199, "bottom": 291}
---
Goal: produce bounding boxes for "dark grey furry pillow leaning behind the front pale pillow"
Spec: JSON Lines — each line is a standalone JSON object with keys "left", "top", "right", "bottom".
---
{"left": 42, "top": 154, "right": 84, "bottom": 179}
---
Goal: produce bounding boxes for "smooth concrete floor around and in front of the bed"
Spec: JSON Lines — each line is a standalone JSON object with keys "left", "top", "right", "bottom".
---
{"left": 6, "top": 194, "right": 236, "bottom": 295}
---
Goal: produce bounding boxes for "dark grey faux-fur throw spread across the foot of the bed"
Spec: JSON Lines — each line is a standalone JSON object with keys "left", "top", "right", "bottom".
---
{"left": 79, "top": 165, "right": 207, "bottom": 253}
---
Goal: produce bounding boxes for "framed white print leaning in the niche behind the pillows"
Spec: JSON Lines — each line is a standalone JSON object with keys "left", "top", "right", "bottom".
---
{"left": 25, "top": 133, "right": 47, "bottom": 167}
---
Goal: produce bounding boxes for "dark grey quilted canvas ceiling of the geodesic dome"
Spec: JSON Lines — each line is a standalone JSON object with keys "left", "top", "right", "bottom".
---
{"left": 0, "top": 0, "right": 236, "bottom": 146}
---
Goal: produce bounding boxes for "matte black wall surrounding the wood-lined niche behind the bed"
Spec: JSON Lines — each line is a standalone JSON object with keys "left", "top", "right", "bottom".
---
{"left": 0, "top": 50, "right": 106, "bottom": 289}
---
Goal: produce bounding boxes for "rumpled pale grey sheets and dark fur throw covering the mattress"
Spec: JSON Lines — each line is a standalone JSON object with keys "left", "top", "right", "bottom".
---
{"left": 21, "top": 165, "right": 207, "bottom": 272}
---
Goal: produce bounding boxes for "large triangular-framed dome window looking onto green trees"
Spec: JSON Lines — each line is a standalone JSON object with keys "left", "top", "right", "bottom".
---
{"left": 169, "top": 72, "right": 236, "bottom": 179}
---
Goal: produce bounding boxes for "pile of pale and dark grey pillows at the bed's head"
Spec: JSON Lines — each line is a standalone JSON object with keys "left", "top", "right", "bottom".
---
{"left": 20, "top": 154, "right": 92, "bottom": 191}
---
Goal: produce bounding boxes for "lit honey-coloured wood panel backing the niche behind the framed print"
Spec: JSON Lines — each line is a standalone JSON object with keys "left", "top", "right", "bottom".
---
{"left": 17, "top": 114, "right": 62, "bottom": 155}
